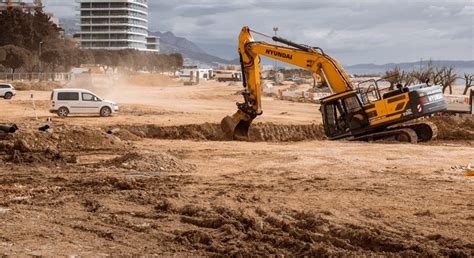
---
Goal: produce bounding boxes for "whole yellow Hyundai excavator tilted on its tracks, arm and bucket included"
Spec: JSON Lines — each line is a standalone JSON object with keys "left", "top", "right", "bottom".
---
{"left": 221, "top": 27, "right": 447, "bottom": 143}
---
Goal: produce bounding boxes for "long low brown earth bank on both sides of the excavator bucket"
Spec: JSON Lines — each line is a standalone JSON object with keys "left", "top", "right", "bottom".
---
{"left": 119, "top": 123, "right": 325, "bottom": 142}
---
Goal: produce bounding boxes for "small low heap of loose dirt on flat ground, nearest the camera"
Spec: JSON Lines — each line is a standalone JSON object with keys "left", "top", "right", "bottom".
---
{"left": 100, "top": 152, "right": 195, "bottom": 173}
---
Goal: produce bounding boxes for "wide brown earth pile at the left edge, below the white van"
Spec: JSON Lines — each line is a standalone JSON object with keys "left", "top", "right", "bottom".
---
{"left": 0, "top": 125, "right": 126, "bottom": 164}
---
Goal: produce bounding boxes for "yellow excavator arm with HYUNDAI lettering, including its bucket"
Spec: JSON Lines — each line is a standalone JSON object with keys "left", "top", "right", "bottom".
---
{"left": 221, "top": 27, "right": 352, "bottom": 140}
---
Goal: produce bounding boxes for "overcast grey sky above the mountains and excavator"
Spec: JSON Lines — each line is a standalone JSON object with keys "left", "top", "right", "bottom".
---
{"left": 43, "top": 0, "right": 474, "bottom": 65}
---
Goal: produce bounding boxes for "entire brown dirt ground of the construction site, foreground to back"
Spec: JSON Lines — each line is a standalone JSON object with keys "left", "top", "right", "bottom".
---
{"left": 0, "top": 76, "right": 474, "bottom": 257}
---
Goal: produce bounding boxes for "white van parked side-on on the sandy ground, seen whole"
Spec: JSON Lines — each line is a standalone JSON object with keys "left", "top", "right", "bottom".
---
{"left": 49, "top": 89, "right": 119, "bottom": 117}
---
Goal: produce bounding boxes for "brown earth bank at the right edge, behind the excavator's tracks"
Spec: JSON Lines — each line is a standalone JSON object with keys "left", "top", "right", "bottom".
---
{"left": 430, "top": 116, "right": 474, "bottom": 140}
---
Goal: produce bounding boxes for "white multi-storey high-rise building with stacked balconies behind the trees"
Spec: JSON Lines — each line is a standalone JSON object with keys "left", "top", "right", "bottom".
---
{"left": 76, "top": 0, "right": 159, "bottom": 52}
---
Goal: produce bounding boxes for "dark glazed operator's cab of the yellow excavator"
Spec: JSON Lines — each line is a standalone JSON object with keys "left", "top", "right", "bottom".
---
{"left": 321, "top": 91, "right": 370, "bottom": 140}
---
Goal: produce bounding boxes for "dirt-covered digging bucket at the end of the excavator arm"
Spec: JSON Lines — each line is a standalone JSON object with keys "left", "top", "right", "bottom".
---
{"left": 221, "top": 110, "right": 253, "bottom": 141}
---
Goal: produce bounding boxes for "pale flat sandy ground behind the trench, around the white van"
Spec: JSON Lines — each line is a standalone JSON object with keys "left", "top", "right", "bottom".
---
{"left": 0, "top": 82, "right": 321, "bottom": 125}
